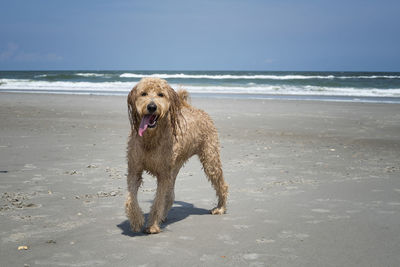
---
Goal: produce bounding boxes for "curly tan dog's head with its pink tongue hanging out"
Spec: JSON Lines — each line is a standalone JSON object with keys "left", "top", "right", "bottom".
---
{"left": 128, "top": 78, "right": 181, "bottom": 136}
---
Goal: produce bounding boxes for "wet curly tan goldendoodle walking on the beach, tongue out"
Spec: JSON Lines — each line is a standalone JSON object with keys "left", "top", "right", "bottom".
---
{"left": 125, "top": 78, "right": 228, "bottom": 234}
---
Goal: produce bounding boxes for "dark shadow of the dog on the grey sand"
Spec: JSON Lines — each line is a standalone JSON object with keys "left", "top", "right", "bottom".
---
{"left": 117, "top": 201, "right": 210, "bottom": 237}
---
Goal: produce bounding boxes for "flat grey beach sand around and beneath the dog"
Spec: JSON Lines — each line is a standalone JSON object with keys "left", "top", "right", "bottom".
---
{"left": 0, "top": 93, "right": 400, "bottom": 266}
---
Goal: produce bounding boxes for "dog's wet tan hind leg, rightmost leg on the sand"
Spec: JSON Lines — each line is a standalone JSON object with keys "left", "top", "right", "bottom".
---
{"left": 199, "top": 140, "right": 228, "bottom": 214}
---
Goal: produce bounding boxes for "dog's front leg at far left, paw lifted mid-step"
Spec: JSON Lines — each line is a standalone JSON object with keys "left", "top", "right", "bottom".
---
{"left": 125, "top": 170, "right": 144, "bottom": 232}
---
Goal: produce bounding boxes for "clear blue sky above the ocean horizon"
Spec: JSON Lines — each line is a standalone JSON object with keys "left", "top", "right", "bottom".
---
{"left": 0, "top": 0, "right": 400, "bottom": 71}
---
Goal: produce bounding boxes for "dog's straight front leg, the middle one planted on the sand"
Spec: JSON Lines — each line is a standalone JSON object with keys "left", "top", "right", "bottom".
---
{"left": 146, "top": 177, "right": 173, "bottom": 234}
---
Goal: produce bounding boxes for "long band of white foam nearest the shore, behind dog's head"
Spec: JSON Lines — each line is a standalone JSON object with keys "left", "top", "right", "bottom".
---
{"left": 0, "top": 79, "right": 400, "bottom": 97}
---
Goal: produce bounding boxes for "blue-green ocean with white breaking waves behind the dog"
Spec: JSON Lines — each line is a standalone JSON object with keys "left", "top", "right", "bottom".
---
{"left": 0, "top": 71, "right": 400, "bottom": 103}
